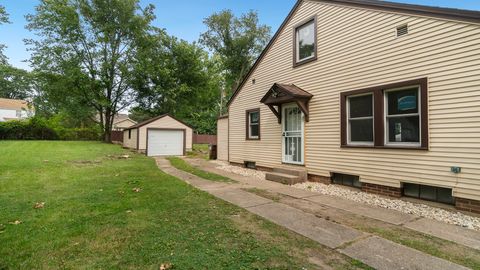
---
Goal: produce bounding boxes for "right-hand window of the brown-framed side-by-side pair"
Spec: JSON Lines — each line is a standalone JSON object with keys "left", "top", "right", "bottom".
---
{"left": 385, "top": 87, "right": 420, "bottom": 145}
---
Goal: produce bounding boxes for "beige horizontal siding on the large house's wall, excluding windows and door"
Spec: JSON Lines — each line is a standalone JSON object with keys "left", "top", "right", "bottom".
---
{"left": 229, "top": 1, "right": 480, "bottom": 200}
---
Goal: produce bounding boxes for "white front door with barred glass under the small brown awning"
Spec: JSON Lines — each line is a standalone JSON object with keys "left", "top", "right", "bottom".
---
{"left": 282, "top": 104, "right": 304, "bottom": 165}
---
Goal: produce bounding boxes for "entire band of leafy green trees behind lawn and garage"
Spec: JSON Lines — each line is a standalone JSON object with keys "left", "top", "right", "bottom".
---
{"left": 0, "top": 3, "right": 270, "bottom": 141}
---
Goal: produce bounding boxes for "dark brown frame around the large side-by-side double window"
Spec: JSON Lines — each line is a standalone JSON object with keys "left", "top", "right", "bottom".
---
{"left": 340, "top": 78, "right": 429, "bottom": 150}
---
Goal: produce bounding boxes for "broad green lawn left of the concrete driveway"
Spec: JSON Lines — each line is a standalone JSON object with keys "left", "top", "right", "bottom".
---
{"left": 0, "top": 141, "right": 363, "bottom": 269}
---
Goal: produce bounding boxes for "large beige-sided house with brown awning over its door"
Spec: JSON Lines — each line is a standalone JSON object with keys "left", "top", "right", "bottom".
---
{"left": 218, "top": 0, "right": 480, "bottom": 212}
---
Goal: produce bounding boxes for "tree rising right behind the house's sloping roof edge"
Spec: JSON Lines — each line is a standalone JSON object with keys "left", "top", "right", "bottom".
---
{"left": 200, "top": 10, "right": 270, "bottom": 109}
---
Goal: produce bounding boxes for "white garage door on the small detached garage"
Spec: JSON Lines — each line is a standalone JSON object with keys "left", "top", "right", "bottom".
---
{"left": 147, "top": 130, "right": 184, "bottom": 156}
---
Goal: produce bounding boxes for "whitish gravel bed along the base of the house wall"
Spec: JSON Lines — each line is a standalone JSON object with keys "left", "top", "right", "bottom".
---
{"left": 293, "top": 182, "right": 480, "bottom": 231}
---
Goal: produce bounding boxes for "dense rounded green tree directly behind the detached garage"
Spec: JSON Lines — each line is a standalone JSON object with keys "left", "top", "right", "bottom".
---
{"left": 132, "top": 31, "right": 220, "bottom": 133}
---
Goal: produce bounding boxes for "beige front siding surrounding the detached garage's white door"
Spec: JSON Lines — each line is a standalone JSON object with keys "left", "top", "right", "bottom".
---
{"left": 138, "top": 115, "right": 193, "bottom": 151}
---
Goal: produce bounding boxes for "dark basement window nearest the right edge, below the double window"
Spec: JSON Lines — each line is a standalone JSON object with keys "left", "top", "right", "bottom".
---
{"left": 403, "top": 183, "right": 455, "bottom": 204}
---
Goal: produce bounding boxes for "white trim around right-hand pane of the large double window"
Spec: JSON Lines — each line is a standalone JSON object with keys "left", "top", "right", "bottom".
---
{"left": 383, "top": 85, "right": 422, "bottom": 148}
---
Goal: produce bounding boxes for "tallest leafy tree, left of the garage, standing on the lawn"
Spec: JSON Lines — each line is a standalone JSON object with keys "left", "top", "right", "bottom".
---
{"left": 26, "top": 0, "right": 154, "bottom": 142}
